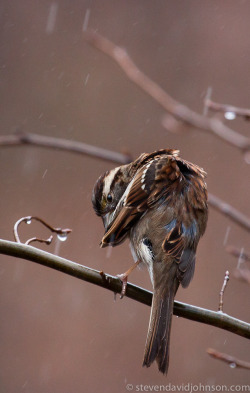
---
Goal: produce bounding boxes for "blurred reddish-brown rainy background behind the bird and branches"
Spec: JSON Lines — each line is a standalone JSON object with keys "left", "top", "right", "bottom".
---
{"left": 0, "top": 0, "right": 250, "bottom": 393}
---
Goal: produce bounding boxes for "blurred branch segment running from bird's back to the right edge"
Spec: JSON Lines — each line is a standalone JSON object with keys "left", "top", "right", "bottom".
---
{"left": 208, "top": 193, "right": 250, "bottom": 231}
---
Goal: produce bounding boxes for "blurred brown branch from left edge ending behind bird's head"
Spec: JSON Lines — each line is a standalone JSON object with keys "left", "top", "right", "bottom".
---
{"left": 0, "top": 132, "right": 131, "bottom": 164}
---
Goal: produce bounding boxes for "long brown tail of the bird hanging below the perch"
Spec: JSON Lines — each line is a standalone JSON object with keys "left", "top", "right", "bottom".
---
{"left": 143, "top": 279, "right": 179, "bottom": 374}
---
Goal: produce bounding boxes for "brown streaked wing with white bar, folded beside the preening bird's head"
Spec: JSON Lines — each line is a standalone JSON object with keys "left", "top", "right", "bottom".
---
{"left": 101, "top": 150, "right": 181, "bottom": 247}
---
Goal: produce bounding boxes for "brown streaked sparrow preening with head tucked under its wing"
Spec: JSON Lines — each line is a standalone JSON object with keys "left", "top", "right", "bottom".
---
{"left": 92, "top": 149, "right": 208, "bottom": 374}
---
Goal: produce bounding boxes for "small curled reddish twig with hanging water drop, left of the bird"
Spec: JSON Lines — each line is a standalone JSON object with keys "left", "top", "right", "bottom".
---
{"left": 13, "top": 216, "right": 72, "bottom": 245}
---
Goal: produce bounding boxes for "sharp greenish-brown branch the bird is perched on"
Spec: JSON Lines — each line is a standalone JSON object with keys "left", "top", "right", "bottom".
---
{"left": 0, "top": 240, "right": 250, "bottom": 339}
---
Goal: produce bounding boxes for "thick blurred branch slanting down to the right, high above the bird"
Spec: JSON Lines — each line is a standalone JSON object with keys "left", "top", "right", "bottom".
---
{"left": 84, "top": 30, "right": 250, "bottom": 152}
